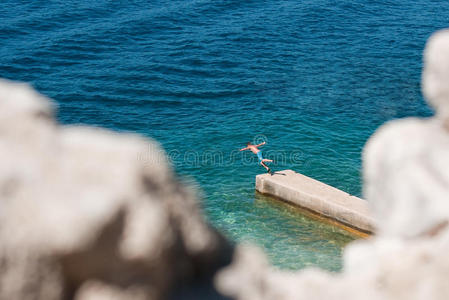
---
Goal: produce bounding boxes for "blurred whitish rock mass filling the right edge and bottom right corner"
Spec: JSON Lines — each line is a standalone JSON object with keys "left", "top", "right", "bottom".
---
{"left": 216, "top": 30, "right": 449, "bottom": 300}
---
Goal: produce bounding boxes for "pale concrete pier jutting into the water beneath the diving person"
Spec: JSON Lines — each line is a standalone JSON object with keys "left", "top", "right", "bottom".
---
{"left": 256, "top": 170, "right": 374, "bottom": 233}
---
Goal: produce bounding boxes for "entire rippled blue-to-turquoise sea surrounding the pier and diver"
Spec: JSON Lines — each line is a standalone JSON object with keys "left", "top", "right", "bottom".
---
{"left": 0, "top": 0, "right": 449, "bottom": 270}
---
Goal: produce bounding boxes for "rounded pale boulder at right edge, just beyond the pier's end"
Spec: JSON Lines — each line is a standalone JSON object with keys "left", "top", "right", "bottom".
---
{"left": 363, "top": 118, "right": 449, "bottom": 237}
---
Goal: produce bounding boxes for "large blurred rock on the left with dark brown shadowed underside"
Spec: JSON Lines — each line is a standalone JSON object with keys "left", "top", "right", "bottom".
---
{"left": 0, "top": 81, "right": 229, "bottom": 300}
